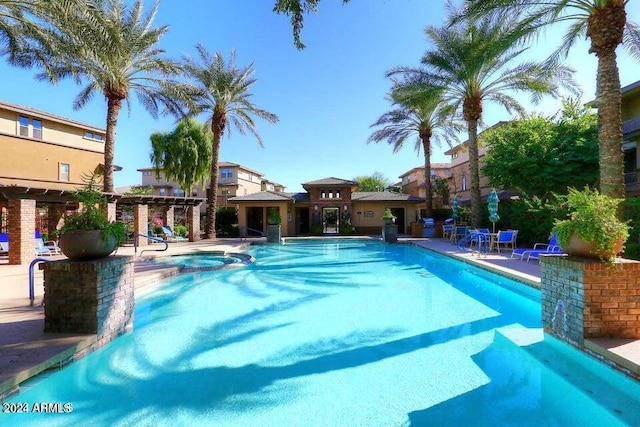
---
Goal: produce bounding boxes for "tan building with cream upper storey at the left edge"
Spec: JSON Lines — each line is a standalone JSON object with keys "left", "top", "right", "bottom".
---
{"left": 0, "top": 101, "right": 105, "bottom": 190}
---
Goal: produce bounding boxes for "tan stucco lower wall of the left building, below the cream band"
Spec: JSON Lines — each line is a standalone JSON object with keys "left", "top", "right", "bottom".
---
{"left": 0, "top": 135, "right": 104, "bottom": 189}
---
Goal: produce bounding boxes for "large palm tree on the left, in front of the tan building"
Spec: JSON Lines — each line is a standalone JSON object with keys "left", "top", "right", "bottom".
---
{"left": 13, "top": 0, "right": 180, "bottom": 192}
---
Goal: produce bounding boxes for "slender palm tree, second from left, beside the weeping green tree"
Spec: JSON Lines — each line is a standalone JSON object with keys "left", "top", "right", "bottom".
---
{"left": 175, "top": 44, "right": 278, "bottom": 239}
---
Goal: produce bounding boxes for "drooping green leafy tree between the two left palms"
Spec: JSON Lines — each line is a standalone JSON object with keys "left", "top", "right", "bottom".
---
{"left": 150, "top": 119, "right": 213, "bottom": 194}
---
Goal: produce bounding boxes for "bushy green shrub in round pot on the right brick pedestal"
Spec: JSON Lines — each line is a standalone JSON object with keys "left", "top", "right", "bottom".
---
{"left": 553, "top": 187, "right": 629, "bottom": 262}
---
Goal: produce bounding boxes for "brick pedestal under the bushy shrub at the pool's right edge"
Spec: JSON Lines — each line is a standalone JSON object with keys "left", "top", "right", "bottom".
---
{"left": 540, "top": 256, "right": 640, "bottom": 346}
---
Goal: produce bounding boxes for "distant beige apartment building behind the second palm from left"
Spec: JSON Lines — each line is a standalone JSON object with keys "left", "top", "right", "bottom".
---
{"left": 138, "top": 162, "right": 284, "bottom": 207}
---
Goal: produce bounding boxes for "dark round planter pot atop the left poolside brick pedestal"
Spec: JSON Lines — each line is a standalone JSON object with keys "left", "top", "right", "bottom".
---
{"left": 58, "top": 230, "right": 117, "bottom": 261}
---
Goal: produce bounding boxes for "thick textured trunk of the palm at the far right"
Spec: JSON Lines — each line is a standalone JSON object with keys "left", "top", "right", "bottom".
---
{"left": 587, "top": 1, "right": 626, "bottom": 198}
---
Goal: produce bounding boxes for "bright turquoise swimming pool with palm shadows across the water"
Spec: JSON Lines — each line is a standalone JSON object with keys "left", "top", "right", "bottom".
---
{"left": 0, "top": 240, "right": 640, "bottom": 426}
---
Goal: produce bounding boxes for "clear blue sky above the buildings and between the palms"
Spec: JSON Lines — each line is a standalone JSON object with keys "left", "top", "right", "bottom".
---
{"left": 0, "top": 0, "right": 640, "bottom": 191}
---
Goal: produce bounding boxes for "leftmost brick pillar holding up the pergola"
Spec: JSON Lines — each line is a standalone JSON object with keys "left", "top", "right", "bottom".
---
{"left": 9, "top": 199, "right": 36, "bottom": 264}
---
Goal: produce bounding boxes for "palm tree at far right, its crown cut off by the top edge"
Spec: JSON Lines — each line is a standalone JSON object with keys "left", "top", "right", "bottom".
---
{"left": 464, "top": 0, "right": 640, "bottom": 198}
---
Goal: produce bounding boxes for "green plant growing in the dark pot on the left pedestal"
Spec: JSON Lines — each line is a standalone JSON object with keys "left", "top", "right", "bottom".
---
{"left": 60, "top": 172, "right": 125, "bottom": 246}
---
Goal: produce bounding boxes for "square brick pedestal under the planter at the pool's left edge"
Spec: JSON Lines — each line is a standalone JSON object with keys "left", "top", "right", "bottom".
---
{"left": 43, "top": 256, "right": 135, "bottom": 351}
